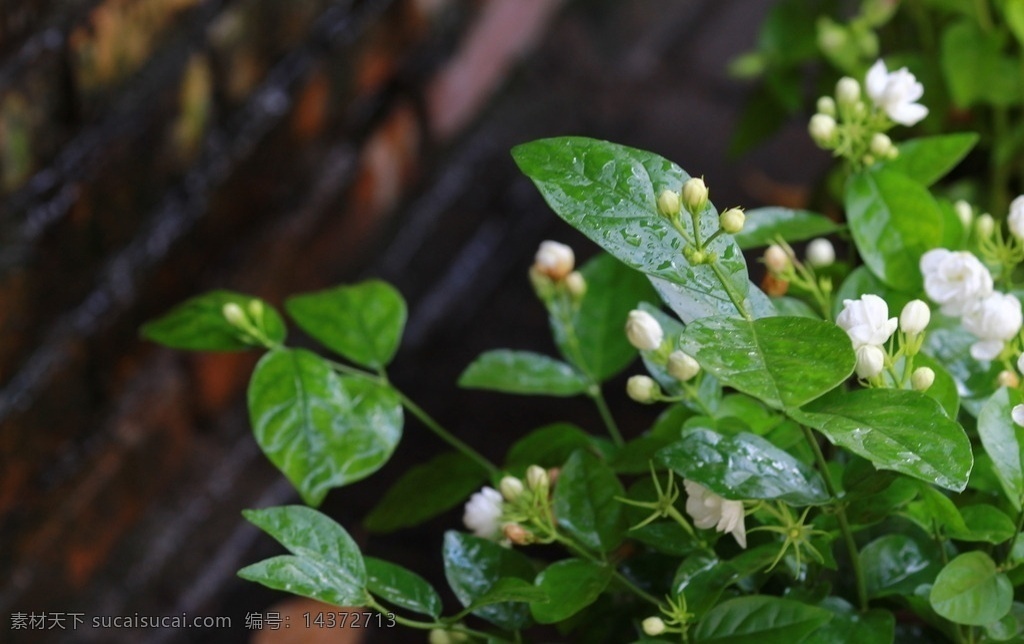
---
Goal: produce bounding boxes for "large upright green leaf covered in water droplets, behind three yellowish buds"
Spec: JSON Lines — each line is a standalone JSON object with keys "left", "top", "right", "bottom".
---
{"left": 512, "top": 137, "right": 750, "bottom": 321}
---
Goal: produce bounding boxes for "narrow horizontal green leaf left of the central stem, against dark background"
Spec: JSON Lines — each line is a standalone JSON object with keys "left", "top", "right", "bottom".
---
{"left": 459, "top": 349, "right": 587, "bottom": 396}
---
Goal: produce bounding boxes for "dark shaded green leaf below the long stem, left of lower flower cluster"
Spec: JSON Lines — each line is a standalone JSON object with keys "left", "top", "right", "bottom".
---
{"left": 362, "top": 452, "right": 487, "bottom": 532}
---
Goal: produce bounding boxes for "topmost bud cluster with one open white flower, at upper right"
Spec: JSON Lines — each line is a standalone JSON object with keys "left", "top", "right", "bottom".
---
{"left": 808, "top": 60, "right": 928, "bottom": 168}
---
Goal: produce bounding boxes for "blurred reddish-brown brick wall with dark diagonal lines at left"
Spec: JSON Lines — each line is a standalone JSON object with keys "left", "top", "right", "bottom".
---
{"left": 0, "top": 0, "right": 560, "bottom": 641}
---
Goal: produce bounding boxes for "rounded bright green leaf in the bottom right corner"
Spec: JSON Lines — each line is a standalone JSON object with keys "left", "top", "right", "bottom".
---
{"left": 928, "top": 550, "right": 1014, "bottom": 627}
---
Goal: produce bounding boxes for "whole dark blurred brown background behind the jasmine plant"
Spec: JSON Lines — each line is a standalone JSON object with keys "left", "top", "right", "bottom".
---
{"left": 0, "top": 0, "right": 827, "bottom": 642}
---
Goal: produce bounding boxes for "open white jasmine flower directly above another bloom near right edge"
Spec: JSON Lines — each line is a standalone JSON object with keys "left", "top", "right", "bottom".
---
{"left": 921, "top": 248, "right": 992, "bottom": 316}
